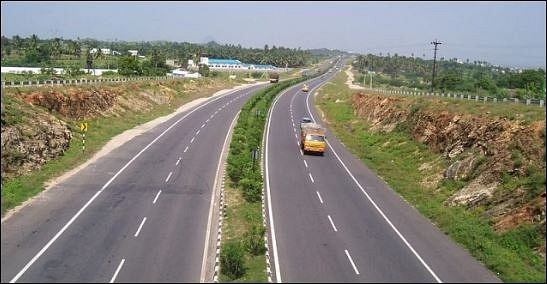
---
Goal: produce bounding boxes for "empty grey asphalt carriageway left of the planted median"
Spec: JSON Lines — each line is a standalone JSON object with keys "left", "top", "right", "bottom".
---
{"left": 1, "top": 81, "right": 268, "bottom": 282}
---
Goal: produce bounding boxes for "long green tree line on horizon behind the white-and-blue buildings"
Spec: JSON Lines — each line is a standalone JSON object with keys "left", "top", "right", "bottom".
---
{"left": 1, "top": 34, "right": 319, "bottom": 76}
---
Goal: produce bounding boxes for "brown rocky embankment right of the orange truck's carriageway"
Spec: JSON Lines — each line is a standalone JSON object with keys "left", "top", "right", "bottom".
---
{"left": 352, "top": 92, "right": 545, "bottom": 256}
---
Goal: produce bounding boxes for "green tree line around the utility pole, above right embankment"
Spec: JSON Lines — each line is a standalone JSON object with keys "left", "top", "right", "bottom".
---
{"left": 353, "top": 53, "right": 545, "bottom": 99}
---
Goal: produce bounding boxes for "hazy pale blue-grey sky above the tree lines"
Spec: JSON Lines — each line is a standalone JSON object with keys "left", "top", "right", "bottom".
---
{"left": 1, "top": 1, "right": 547, "bottom": 70}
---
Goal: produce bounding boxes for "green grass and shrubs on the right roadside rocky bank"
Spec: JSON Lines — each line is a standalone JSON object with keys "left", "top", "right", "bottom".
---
{"left": 316, "top": 68, "right": 546, "bottom": 283}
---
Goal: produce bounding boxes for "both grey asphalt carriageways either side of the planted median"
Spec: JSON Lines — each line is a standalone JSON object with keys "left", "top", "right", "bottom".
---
{"left": 1, "top": 65, "right": 506, "bottom": 283}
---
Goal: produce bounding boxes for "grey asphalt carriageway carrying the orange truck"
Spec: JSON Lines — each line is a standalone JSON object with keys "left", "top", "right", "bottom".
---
{"left": 264, "top": 60, "right": 500, "bottom": 283}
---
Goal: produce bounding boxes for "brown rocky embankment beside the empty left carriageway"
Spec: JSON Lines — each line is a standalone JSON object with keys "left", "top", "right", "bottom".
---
{"left": 1, "top": 77, "right": 229, "bottom": 181}
